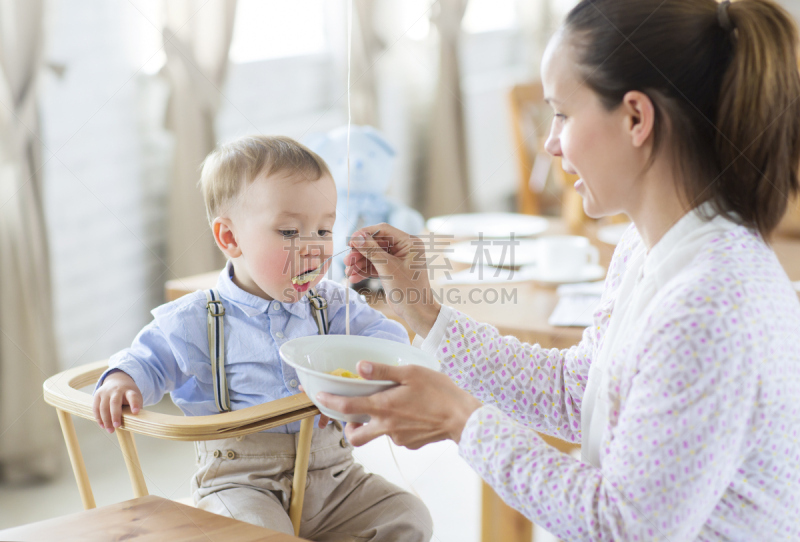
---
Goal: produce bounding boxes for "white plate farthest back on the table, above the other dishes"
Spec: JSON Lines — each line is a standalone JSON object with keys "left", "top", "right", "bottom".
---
{"left": 425, "top": 213, "right": 549, "bottom": 239}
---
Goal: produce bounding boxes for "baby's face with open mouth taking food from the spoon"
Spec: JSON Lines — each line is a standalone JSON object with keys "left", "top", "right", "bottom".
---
{"left": 231, "top": 175, "right": 336, "bottom": 303}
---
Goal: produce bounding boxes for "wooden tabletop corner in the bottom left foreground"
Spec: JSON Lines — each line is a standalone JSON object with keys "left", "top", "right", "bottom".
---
{"left": 0, "top": 495, "right": 303, "bottom": 542}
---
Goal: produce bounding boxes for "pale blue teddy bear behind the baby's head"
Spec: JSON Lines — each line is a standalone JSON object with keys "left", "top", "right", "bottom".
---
{"left": 304, "top": 126, "right": 425, "bottom": 281}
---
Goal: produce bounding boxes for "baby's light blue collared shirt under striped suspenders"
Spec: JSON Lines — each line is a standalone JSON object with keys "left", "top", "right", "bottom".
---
{"left": 97, "top": 262, "right": 409, "bottom": 433}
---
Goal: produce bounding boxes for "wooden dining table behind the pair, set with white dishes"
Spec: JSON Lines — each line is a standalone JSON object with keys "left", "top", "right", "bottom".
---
{"left": 166, "top": 220, "right": 800, "bottom": 542}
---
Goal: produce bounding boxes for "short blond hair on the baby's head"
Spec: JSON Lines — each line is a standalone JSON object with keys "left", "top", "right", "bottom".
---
{"left": 200, "top": 135, "right": 330, "bottom": 224}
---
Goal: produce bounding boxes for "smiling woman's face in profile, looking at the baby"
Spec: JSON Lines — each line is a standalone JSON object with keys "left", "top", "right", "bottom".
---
{"left": 542, "top": 31, "right": 639, "bottom": 218}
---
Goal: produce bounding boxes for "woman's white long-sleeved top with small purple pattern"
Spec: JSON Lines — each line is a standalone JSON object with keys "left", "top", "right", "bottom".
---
{"left": 415, "top": 212, "right": 800, "bottom": 542}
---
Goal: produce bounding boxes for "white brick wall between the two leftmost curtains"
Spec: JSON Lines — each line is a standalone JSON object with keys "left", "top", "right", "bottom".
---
{"left": 41, "top": 0, "right": 171, "bottom": 367}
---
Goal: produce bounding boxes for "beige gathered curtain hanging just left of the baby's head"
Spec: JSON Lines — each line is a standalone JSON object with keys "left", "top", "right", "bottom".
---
{"left": 164, "top": 0, "right": 236, "bottom": 277}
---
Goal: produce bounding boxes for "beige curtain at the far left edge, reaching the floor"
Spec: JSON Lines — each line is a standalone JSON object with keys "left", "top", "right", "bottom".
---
{"left": 0, "top": 0, "right": 59, "bottom": 482}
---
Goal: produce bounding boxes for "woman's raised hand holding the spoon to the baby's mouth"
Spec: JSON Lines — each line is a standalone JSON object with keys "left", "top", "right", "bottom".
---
{"left": 344, "top": 224, "right": 441, "bottom": 337}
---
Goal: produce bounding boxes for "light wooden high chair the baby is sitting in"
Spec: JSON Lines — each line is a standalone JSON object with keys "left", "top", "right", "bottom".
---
{"left": 44, "top": 360, "right": 319, "bottom": 535}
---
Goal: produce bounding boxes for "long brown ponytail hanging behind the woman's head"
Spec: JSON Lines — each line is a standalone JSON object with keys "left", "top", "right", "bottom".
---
{"left": 711, "top": 0, "right": 800, "bottom": 238}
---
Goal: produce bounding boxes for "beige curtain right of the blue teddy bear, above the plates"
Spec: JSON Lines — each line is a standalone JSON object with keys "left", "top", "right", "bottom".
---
{"left": 422, "top": 0, "right": 472, "bottom": 217}
